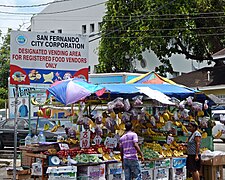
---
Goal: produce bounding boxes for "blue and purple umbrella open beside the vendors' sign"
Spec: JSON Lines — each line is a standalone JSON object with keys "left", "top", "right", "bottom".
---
{"left": 47, "top": 78, "right": 105, "bottom": 105}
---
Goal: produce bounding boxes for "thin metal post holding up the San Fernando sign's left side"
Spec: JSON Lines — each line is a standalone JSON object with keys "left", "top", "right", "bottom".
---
{"left": 13, "top": 85, "right": 18, "bottom": 180}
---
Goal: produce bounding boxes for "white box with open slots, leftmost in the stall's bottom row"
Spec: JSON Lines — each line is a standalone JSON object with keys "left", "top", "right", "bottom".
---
{"left": 46, "top": 166, "right": 77, "bottom": 180}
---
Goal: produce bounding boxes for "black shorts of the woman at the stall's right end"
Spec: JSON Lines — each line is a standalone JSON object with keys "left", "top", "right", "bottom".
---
{"left": 186, "top": 154, "right": 201, "bottom": 172}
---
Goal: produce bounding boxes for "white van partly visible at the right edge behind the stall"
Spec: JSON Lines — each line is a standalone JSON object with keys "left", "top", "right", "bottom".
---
{"left": 212, "top": 110, "right": 225, "bottom": 142}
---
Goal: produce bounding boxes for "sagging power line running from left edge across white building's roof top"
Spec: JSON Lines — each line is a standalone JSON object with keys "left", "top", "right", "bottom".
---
{"left": 0, "top": 2, "right": 106, "bottom": 15}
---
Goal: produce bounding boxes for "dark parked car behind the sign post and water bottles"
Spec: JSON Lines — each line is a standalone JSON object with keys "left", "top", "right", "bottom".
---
{"left": 0, "top": 118, "right": 66, "bottom": 149}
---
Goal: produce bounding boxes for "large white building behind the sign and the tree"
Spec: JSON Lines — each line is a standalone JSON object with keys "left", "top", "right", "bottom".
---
{"left": 29, "top": 0, "right": 213, "bottom": 75}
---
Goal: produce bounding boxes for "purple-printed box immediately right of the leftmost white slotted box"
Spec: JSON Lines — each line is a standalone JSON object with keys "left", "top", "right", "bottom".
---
{"left": 78, "top": 164, "right": 105, "bottom": 180}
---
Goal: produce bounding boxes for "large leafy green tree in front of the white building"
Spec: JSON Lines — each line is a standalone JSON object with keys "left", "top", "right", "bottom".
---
{"left": 97, "top": 0, "right": 225, "bottom": 73}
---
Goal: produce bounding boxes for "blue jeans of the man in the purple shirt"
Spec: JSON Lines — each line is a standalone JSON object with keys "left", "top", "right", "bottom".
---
{"left": 123, "top": 159, "right": 142, "bottom": 180}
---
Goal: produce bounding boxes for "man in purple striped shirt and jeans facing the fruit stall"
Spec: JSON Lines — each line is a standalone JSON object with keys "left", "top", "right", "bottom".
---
{"left": 120, "top": 122, "right": 144, "bottom": 180}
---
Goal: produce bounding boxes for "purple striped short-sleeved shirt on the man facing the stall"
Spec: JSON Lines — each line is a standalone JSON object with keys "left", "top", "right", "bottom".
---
{"left": 120, "top": 131, "right": 138, "bottom": 160}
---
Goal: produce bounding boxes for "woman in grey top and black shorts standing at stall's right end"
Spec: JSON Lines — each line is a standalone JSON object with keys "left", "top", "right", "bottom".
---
{"left": 187, "top": 121, "right": 201, "bottom": 180}
